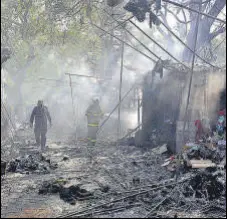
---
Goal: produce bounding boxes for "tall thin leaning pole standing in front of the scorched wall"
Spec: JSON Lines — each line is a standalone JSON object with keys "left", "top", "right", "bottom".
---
{"left": 183, "top": 2, "right": 202, "bottom": 142}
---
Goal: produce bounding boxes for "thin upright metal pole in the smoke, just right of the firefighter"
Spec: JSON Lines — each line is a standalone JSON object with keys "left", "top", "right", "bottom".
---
{"left": 117, "top": 40, "right": 124, "bottom": 139}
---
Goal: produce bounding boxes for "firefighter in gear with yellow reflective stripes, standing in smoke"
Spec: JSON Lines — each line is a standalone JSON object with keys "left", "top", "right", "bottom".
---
{"left": 86, "top": 99, "right": 103, "bottom": 146}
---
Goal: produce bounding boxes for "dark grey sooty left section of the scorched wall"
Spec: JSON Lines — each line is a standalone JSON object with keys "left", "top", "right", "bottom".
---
{"left": 142, "top": 68, "right": 185, "bottom": 151}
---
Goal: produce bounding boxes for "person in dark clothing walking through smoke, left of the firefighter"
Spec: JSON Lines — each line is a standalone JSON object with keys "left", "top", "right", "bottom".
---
{"left": 30, "top": 100, "right": 51, "bottom": 151}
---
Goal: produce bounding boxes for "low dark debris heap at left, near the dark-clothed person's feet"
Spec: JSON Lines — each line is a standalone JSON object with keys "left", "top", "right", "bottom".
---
{"left": 7, "top": 154, "right": 58, "bottom": 174}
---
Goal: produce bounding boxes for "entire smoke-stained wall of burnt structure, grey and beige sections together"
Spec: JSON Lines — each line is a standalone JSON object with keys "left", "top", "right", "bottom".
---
{"left": 135, "top": 63, "right": 226, "bottom": 153}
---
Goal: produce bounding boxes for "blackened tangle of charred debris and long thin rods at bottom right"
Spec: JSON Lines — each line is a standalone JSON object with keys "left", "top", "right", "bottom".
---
{"left": 57, "top": 173, "right": 226, "bottom": 218}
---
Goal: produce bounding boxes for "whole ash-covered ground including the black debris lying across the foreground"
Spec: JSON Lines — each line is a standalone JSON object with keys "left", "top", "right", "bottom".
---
{"left": 1, "top": 128, "right": 226, "bottom": 218}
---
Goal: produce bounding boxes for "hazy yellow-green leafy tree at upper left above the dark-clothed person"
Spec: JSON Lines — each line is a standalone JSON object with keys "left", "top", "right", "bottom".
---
{"left": 1, "top": 0, "right": 105, "bottom": 115}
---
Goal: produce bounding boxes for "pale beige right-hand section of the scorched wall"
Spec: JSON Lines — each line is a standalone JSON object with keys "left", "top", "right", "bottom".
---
{"left": 176, "top": 70, "right": 226, "bottom": 152}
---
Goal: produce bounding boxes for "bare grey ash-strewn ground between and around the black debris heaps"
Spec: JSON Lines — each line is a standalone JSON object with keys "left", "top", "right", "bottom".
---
{"left": 1, "top": 128, "right": 174, "bottom": 218}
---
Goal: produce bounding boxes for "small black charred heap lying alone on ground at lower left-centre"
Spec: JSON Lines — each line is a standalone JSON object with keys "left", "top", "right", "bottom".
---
{"left": 39, "top": 178, "right": 93, "bottom": 205}
